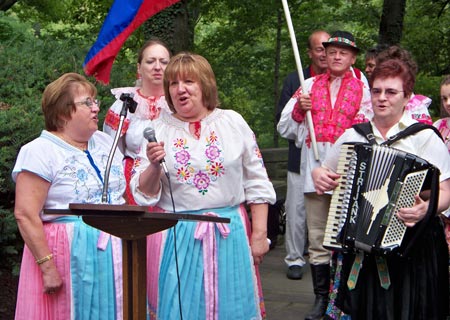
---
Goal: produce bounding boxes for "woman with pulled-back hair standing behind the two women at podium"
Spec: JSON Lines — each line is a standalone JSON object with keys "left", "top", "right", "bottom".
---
{"left": 103, "top": 38, "right": 171, "bottom": 204}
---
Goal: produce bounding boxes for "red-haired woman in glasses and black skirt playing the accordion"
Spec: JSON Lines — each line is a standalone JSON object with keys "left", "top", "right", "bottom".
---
{"left": 312, "top": 59, "right": 450, "bottom": 319}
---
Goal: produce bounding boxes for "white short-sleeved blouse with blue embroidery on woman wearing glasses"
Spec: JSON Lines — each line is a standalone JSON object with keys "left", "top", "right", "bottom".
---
{"left": 12, "top": 130, "right": 125, "bottom": 221}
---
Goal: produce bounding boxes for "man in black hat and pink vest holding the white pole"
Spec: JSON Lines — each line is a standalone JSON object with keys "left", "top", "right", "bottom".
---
{"left": 279, "top": 31, "right": 371, "bottom": 319}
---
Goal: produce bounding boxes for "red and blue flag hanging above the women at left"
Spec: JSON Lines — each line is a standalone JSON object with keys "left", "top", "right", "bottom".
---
{"left": 83, "top": 0, "right": 180, "bottom": 84}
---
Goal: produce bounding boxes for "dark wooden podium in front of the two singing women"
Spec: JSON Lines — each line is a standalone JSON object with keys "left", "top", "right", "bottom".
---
{"left": 44, "top": 203, "right": 230, "bottom": 320}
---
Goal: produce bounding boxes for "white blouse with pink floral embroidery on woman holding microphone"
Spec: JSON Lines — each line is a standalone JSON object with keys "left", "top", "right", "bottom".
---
{"left": 131, "top": 109, "right": 276, "bottom": 212}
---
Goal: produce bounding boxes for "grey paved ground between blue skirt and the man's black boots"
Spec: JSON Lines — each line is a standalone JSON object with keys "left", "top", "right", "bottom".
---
{"left": 260, "top": 236, "right": 314, "bottom": 320}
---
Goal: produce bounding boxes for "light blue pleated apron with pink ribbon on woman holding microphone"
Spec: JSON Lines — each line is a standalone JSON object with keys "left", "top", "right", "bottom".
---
{"left": 156, "top": 206, "right": 261, "bottom": 320}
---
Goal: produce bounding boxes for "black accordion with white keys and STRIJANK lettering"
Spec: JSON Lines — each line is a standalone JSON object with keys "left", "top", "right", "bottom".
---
{"left": 323, "top": 143, "right": 439, "bottom": 254}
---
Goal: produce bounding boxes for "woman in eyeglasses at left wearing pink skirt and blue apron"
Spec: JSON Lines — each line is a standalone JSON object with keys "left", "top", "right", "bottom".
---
{"left": 12, "top": 73, "right": 125, "bottom": 320}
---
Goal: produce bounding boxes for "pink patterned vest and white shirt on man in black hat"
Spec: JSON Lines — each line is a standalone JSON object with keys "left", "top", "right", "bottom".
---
{"left": 278, "top": 71, "right": 373, "bottom": 193}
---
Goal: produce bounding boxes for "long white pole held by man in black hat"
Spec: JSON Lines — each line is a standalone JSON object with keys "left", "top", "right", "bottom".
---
{"left": 281, "top": 0, "right": 319, "bottom": 161}
